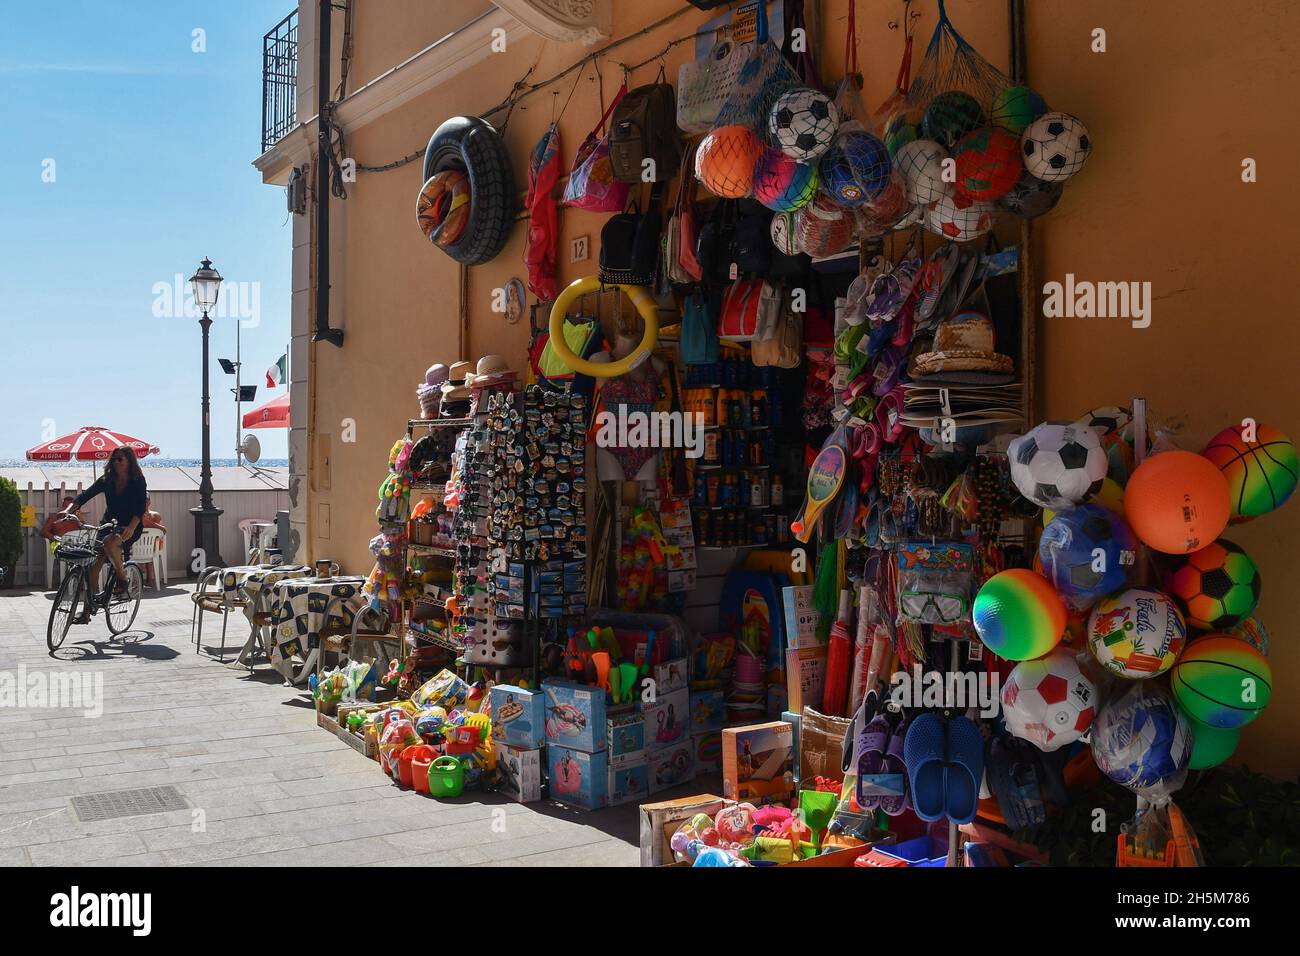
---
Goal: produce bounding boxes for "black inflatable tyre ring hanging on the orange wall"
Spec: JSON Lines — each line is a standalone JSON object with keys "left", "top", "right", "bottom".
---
{"left": 424, "top": 116, "right": 515, "bottom": 265}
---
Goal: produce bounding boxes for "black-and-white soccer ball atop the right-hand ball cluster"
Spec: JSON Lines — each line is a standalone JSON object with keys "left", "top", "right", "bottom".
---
{"left": 1006, "top": 421, "right": 1106, "bottom": 510}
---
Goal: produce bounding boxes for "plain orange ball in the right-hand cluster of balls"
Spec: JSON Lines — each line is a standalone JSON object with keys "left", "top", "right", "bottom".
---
{"left": 1125, "top": 451, "right": 1231, "bottom": 554}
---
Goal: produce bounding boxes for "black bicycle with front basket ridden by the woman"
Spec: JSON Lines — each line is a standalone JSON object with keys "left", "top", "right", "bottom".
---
{"left": 46, "top": 519, "right": 144, "bottom": 652}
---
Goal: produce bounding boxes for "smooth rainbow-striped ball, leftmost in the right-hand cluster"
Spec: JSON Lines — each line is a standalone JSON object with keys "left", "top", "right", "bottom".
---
{"left": 972, "top": 567, "right": 1066, "bottom": 661}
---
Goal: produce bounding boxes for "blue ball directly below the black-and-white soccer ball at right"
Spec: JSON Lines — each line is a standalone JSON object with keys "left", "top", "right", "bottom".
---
{"left": 1039, "top": 505, "right": 1138, "bottom": 609}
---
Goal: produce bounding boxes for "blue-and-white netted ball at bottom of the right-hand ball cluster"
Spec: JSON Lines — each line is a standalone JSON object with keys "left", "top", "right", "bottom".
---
{"left": 1092, "top": 684, "right": 1192, "bottom": 791}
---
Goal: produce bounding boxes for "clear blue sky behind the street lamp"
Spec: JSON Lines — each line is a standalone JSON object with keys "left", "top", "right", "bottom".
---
{"left": 0, "top": 0, "right": 294, "bottom": 458}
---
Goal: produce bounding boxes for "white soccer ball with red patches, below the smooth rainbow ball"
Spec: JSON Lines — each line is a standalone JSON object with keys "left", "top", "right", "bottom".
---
{"left": 1002, "top": 646, "right": 1097, "bottom": 753}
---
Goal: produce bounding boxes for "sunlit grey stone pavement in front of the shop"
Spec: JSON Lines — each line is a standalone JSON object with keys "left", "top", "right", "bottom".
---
{"left": 0, "top": 584, "right": 719, "bottom": 866}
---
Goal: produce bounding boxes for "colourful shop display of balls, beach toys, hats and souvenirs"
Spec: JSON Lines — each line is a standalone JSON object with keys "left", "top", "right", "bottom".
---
{"left": 301, "top": 0, "right": 1300, "bottom": 866}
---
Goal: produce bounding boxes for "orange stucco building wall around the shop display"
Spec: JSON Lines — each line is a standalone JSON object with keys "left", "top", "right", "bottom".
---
{"left": 299, "top": 0, "right": 1300, "bottom": 775}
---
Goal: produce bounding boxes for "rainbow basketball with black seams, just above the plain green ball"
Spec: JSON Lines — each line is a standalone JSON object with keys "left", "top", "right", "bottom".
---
{"left": 1170, "top": 633, "right": 1273, "bottom": 730}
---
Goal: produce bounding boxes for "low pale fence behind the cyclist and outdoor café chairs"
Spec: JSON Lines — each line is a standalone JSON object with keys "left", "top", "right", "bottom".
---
{"left": 0, "top": 468, "right": 289, "bottom": 588}
